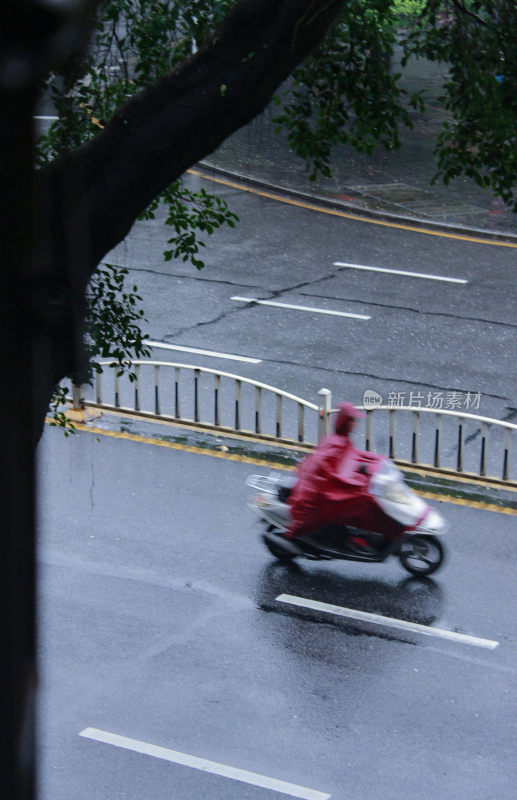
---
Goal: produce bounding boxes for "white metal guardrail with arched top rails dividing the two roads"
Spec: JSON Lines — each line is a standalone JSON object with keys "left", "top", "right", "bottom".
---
{"left": 72, "top": 360, "right": 517, "bottom": 487}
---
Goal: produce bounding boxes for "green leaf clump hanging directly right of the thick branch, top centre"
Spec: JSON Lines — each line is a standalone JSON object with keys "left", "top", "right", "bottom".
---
{"left": 274, "top": 0, "right": 422, "bottom": 180}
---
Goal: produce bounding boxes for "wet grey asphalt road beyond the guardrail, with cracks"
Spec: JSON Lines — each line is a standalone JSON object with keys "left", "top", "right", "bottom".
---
{"left": 107, "top": 171, "right": 517, "bottom": 419}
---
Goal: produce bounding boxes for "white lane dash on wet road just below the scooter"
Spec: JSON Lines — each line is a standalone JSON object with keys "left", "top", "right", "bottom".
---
{"left": 276, "top": 594, "right": 499, "bottom": 650}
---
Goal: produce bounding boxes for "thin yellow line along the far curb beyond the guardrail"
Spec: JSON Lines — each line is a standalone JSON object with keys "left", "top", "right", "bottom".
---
{"left": 187, "top": 169, "right": 517, "bottom": 248}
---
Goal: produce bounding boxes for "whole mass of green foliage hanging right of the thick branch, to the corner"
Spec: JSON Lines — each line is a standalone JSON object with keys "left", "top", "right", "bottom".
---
{"left": 275, "top": 0, "right": 517, "bottom": 206}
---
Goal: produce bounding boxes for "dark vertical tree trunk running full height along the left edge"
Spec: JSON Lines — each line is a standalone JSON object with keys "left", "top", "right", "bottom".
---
{"left": 0, "top": 0, "right": 99, "bottom": 800}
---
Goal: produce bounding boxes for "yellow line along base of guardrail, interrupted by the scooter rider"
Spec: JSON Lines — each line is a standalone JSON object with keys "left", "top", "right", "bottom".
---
{"left": 50, "top": 419, "right": 517, "bottom": 516}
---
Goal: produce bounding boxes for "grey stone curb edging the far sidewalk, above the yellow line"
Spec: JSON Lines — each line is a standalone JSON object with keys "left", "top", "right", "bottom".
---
{"left": 196, "top": 161, "right": 517, "bottom": 246}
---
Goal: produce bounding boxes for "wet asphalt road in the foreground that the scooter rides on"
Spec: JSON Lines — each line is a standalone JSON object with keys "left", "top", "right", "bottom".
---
{"left": 39, "top": 429, "right": 517, "bottom": 800}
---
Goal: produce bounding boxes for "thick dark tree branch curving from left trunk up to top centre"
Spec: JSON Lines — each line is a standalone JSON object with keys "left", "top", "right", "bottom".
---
{"left": 33, "top": 0, "right": 347, "bottom": 387}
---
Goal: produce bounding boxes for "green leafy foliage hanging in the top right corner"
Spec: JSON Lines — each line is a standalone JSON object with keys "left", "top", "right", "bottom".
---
{"left": 405, "top": 0, "right": 517, "bottom": 211}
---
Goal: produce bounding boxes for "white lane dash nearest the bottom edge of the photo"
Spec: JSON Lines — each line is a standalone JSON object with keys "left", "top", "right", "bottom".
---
{"left": 79, "top": 728, "right": 331, "bottom": 800}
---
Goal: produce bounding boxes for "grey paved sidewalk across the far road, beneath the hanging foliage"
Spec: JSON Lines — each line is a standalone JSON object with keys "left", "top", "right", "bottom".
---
{"left": 203, "top": 51, "right": 517, "bottom": 237}
